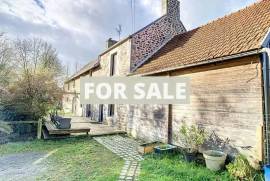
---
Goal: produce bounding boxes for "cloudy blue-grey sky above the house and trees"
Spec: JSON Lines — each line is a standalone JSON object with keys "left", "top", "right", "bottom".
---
{"left": 0, "top": 0, "right": 257, "bottom": 75}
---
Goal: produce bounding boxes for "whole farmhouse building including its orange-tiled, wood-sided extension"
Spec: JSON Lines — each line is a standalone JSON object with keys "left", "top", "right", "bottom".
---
{"left": 63, "top": 0, "right": 270, "bottom": 164}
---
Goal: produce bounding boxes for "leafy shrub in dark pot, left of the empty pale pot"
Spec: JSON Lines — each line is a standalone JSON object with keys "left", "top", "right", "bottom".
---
{"left": 180, "top": 123, "right": 207, "bottom": 162}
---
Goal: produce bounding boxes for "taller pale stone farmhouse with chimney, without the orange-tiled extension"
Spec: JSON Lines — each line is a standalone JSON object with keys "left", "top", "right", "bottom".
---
{"left": 63, "top": 0, "right": 186, "bottom": 121}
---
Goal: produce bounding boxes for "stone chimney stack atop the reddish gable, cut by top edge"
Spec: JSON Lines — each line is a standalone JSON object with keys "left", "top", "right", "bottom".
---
{"left": 161, "top": 0, "right": 180, "bottom": 17}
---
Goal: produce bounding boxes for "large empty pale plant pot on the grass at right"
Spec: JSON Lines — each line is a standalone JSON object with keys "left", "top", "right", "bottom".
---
{"left": 203, "top": 150, "right": 227, "bottom": 171}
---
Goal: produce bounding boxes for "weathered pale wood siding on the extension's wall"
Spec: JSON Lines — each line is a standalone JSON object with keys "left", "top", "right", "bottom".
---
{"left": 171, "top": 56, "right": 263, "bottom": 163}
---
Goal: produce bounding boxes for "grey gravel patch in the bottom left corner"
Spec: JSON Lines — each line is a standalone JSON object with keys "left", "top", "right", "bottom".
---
{"left": 0, "top": 153, "right": 46, "bottom": 181}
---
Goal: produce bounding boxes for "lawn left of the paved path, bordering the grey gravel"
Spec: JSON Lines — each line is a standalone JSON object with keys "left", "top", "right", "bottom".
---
{"left": 0, "top": 137, "right": 124, "bottom": 181}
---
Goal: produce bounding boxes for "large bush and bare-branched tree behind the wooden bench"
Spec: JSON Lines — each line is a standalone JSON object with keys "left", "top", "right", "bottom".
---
{"left": 0, "top": 39, "right": 62, "bottom": 120}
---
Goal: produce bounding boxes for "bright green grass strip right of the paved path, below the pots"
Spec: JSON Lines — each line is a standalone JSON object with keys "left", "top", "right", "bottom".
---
{"left": 139, "top": 155, "right": 232, "bottom": 181}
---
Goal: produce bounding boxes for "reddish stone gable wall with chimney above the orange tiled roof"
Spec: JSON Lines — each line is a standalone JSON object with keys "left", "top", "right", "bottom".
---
{"left": 130, "top": 0, "right": 186, "bottom": 71}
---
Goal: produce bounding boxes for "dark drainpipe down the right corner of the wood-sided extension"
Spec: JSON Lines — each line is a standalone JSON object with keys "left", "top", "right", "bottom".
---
{"left": 261, "top": 49, "right": 270, "bottom": 164}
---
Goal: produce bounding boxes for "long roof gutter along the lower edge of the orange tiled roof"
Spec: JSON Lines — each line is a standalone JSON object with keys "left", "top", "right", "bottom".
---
{"left": 128, "top": 49, "right": 261, "bottom": 76}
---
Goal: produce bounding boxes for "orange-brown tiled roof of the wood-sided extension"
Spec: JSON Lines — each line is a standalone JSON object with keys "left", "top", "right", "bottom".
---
{"left": 135, "top": 0, "right": 270, "bottom": 74}
